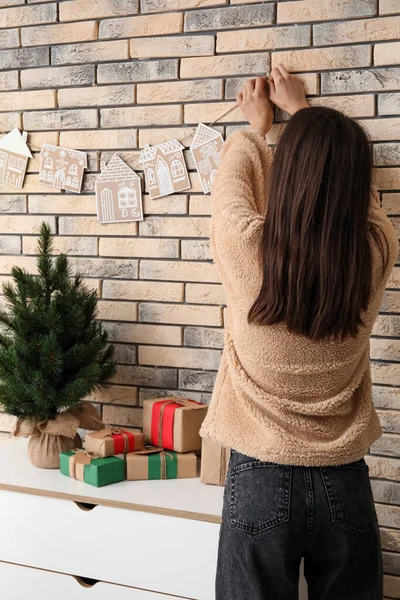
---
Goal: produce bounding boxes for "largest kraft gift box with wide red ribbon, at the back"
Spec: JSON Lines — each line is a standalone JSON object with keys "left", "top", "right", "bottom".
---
{"left": 143, "top": 398, "right": 207, "bottom": 452}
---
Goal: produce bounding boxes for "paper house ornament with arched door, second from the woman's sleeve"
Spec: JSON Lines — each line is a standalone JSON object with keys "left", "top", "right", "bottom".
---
{"left": 140, "top": 140, "right": 190, "bottom": 198}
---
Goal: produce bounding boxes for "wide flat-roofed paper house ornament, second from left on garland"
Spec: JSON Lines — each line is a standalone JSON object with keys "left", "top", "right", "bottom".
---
{"left": 39, "top": 144, "right": 87, "bottom": 192}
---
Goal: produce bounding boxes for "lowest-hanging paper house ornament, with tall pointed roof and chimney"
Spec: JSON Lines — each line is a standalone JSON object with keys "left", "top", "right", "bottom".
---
{"left": 96, "top": 154, "right": 143, "bottom": 223}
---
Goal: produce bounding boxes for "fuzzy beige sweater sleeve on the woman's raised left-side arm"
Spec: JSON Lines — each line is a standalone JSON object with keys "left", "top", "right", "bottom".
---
{"left": 211, "top": 130, "right": 272, "bottom": 310}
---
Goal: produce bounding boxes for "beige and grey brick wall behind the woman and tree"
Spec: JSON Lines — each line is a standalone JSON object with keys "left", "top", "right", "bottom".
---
{"left": 0, "top": 0, "right": 400, "bottom": 598}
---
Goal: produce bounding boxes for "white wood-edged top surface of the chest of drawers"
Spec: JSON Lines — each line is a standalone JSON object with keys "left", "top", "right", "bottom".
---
{"left": 0, "top": 439, "right": 223, "bottom": 523}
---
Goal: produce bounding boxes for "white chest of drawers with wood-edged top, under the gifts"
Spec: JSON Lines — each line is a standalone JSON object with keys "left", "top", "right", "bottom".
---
{"left": 0, "top": 439, "right": 306, "bottom": 600}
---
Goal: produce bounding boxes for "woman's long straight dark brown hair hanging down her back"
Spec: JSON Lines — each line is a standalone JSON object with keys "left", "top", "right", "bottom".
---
{"left": 248, "top": 107, "right": 387, "bottom": 340}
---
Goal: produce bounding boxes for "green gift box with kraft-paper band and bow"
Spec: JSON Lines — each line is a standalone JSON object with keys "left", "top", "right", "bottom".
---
{"left": 60, "top": 450, "right": 125, "bottom": 487}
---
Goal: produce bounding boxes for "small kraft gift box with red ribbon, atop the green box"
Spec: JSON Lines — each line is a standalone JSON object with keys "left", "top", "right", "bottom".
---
{"left": 85, "top": 427, "right": 144, "bottom": 456}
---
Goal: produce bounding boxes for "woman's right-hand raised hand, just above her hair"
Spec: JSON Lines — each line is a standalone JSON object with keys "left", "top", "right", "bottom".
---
{"left": 268, "top": 65, "right": 308, "bottom": 115}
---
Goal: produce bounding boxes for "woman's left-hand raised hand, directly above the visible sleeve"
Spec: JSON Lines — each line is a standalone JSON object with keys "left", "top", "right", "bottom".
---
{"left": 236, "top": 77, "right": 274, "bottom": 135}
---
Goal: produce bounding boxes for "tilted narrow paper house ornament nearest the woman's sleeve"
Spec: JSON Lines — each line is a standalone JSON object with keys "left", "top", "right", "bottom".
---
{"left": 190, "top": 123, "right": 224, "bottom": 194}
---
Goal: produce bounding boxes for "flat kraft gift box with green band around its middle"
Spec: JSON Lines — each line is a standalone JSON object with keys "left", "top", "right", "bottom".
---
{"left": 126, "top": 448, "right": 197, "bottom": 481}
